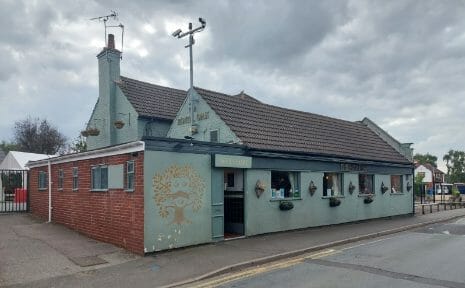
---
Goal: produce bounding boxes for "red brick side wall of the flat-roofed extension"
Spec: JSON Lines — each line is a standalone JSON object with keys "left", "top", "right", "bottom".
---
{"left": 29, "top": 152, "right": 144, "bottom": 254}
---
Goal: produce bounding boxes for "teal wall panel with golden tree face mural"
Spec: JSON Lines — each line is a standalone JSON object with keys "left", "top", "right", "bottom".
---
{"left": 144, "top": 151, "right": 212, "bottom": 252}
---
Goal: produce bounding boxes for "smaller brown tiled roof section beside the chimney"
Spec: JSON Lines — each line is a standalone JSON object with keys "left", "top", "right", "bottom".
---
{"left": 118, "top": 76, "right": 187, "bottom": 120}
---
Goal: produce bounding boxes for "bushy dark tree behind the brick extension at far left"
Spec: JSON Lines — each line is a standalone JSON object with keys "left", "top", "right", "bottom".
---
{"left": 14, "top": 117, "right": 66, "bottom": 155}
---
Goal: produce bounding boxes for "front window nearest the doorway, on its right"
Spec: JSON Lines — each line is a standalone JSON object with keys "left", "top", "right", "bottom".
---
{"left": 271, "top": 171, "right": 300, "bottom": 199}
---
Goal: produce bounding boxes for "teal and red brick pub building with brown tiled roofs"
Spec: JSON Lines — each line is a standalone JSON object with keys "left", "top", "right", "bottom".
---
{"left": 28, "top": 34, "right": 413, "bottom": 254}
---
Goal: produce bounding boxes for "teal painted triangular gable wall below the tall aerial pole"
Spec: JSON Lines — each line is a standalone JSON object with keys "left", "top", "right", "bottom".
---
{"left": 168, "top": 91, "right": 240, "bottom": 143}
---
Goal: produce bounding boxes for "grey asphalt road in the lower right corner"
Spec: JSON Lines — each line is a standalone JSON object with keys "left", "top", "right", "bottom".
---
{"left": 193, "top": 218, "right": 465, "bottom": 288}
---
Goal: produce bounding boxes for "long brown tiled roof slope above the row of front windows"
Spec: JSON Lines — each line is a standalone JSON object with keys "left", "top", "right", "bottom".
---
{"left": 196, "top": 88, "right": 409, "bottom": 163}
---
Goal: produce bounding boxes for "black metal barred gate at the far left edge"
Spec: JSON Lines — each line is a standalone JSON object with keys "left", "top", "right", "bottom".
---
{"left": 0, "top": 170, "right": 29, "bottom": 213}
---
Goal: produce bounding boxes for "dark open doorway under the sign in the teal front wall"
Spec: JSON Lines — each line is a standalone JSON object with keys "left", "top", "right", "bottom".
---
{"left": 224, "top": 169, "right": 244, "bottom": 239}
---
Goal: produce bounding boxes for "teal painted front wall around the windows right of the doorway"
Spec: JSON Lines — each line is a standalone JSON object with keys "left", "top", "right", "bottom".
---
{"left": 245, "top": 169, "right": 413, "bottom": 236}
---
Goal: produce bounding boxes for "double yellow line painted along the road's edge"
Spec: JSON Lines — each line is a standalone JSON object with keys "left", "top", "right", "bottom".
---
{"left": 190, "top": 249, "right": 338, "bottom": 288}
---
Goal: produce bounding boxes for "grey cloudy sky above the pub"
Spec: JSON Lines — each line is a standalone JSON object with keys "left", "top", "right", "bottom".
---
{"left": 0, "top": 0, "right": 465, "bottom": 169}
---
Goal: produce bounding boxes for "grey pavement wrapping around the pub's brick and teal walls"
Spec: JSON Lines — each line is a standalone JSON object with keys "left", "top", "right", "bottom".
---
{"left": 0, "top": 209, "right": 465, "bottom": 288}
